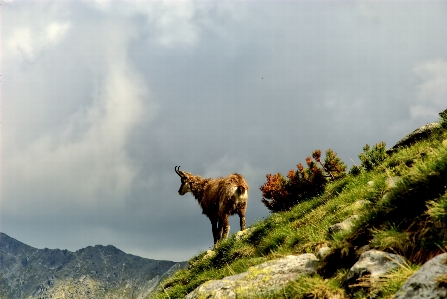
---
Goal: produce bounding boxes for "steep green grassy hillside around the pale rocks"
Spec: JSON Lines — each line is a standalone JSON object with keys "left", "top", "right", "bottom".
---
{"left": 151, "top": 118, "right": 447, "bottom": 298}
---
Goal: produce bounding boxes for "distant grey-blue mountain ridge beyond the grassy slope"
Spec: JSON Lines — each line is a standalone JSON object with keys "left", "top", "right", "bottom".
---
{"left": 0, "top": 233, "right": 186, "bottom": 299}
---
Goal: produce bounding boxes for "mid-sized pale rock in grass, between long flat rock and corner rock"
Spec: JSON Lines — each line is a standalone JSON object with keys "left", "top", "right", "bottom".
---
{"left": 346, "top": 250, "right": 407, "bottom": 290}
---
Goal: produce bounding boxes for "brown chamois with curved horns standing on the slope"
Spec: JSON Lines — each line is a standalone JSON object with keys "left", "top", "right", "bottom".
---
{"left": 174, "top": 166, "right": 248, "bottom": 246}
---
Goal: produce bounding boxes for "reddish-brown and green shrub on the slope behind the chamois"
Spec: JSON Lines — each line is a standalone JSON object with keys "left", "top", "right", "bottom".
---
{"left": 260, "top": 149, "right": 346, "bottom": 212}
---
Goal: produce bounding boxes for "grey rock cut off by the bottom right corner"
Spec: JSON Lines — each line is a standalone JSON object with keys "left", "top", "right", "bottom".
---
{"left": 393, "top": 253, "right": 447, "bottom": 299}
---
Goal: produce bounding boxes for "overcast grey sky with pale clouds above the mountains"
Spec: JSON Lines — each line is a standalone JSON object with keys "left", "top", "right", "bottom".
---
{"left": 0, "top": 0, "right": 447, "bottom": 261}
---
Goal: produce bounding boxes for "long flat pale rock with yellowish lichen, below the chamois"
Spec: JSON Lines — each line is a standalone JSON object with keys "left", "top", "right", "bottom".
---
{"left": 185, "top": 253, "right": 318, "bottom": 299}
